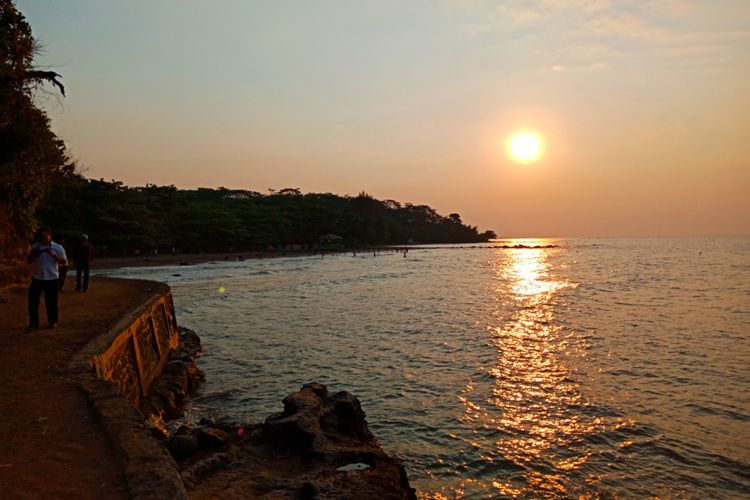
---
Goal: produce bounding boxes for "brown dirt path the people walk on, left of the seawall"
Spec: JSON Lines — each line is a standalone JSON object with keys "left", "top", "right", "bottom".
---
{"left": 0, "top": 277, "right": 159, "bottom": 499}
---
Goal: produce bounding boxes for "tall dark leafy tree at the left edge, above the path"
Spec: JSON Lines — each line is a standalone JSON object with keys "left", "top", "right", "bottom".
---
{"left": 0, "top": 0, "right": 73, "bottom": 284}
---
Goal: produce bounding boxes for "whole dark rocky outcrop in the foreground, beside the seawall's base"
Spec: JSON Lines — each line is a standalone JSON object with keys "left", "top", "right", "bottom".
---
{"left": 167, "top": 383, "right": 416, "bottom": 499}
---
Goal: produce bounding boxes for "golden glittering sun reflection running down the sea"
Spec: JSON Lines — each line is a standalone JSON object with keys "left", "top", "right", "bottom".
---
{"left": 452, "top": 240, "right": 601, "bottom": 496}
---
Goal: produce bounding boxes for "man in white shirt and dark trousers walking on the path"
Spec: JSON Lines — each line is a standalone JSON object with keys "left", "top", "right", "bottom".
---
{"left": 26, "top": 227, "right": 68, "bottom": 332}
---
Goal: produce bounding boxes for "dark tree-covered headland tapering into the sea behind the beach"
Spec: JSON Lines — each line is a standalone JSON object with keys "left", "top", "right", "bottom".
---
{"left": 37, "top": 175, "right": 494, "bottom": 255}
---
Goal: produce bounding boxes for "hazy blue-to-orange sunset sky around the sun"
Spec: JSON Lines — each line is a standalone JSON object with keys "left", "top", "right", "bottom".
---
{"left": 17, "top": 0, "right": 750, "bottom": 237}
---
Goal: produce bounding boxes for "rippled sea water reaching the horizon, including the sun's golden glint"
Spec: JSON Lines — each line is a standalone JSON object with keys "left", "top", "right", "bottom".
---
{"left": 107, "top": 238, "right": 750, "bottom": 498}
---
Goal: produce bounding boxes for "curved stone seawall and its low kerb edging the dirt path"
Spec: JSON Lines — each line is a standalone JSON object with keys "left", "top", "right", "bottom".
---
{"left": 69, "top": 282, "right": 187, "bottom": 500}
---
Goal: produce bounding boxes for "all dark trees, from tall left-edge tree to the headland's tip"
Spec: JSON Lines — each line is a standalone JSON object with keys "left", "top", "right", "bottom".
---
{"left": 0, "top": 0, "right": 494, "bottom": 284}
